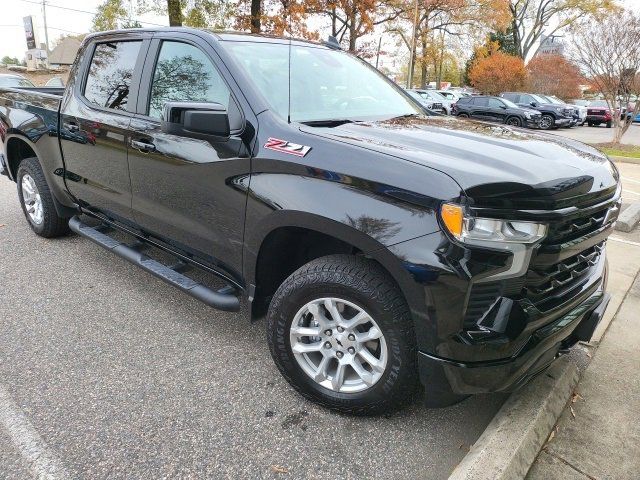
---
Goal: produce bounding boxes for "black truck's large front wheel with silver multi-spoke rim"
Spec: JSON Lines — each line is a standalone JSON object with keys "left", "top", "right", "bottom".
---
{"left": 267, "top": 255, "right": 419, "bottom": 415}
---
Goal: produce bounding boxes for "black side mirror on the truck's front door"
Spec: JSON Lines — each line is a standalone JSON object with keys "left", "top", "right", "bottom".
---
{"left": 162, "top": 102, "right": 231, "bottom": 139}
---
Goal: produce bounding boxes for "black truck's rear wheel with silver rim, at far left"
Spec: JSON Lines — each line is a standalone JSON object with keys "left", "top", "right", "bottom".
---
{"left": 16, "top": 157, "right": 69, "bottom": 238}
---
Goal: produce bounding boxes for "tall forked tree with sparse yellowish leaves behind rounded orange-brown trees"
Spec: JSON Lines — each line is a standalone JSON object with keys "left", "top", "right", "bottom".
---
{"left": 509, "top": 0, "right": 617, "bottom": 59}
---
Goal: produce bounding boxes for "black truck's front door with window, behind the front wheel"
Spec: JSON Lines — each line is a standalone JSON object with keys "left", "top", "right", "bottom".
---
{"left": 129, "top": 33, "right": 253, "bottom": 271}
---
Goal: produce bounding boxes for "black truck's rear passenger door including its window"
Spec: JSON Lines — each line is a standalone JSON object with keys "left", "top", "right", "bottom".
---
{"left": 60, "top": 35, "right": 150, "bottom": 220}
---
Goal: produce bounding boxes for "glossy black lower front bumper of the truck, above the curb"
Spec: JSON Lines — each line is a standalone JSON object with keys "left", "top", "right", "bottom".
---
{"left": 418, "top": 288, "right": 610, "bottom": 394}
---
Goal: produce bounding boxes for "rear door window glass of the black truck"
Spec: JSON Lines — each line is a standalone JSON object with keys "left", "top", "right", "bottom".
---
{"left": 84, "top": 41, "right": 142, "bottom": 110}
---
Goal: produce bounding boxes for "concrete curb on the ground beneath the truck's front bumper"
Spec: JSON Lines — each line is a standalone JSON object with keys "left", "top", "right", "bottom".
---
{"left": 449, "top": 357, "right": 579, "bottom": 480}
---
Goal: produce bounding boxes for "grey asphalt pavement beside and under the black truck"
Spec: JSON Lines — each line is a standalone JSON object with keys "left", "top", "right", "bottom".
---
{"left": 0, "top": 181, "right": 508, "bottom": 480}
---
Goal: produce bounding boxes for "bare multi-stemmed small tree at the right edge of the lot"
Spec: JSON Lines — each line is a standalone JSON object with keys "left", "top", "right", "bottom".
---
{"left": 572, "top": 10, "right": 640, "bottom": 144}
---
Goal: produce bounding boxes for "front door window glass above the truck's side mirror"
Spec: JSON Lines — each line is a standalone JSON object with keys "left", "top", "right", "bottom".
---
{"left": 149, "top": 41, "right": 230, "bottom": 119}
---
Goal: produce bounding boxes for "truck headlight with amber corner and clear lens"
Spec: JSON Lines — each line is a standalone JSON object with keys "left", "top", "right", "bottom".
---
{"left": 440, "top": 203, "right": 547, "bottom": 244}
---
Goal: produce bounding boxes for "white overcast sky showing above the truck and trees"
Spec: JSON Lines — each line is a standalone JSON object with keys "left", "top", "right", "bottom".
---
{"left": 0, "top": 0, "right": 640, "bottom": 59}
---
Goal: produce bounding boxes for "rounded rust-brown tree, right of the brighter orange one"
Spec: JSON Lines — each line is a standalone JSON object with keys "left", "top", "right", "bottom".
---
{"left": 527, "top": 54, "right": 584, "bottom": 100}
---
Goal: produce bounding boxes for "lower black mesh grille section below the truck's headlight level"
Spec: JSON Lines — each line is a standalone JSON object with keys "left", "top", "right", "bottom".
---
{"left": 524, "top": 242, "right": 605, "bottom": 310}
